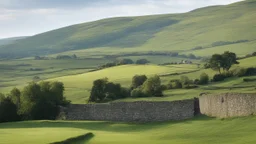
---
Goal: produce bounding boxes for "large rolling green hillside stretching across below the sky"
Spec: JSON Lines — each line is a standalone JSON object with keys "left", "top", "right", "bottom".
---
{"left": 0, "top": 0, "right": 256, "bottom": 57}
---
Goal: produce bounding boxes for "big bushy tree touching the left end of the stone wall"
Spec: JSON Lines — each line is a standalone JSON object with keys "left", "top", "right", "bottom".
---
{"left": 19, "top": 82, "right": 69, "bottom": 120}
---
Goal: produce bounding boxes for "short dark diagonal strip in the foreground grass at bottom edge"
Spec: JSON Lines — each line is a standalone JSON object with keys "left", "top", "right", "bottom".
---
{"left": 50, "top": 133, "right": 94, "bottom": 144}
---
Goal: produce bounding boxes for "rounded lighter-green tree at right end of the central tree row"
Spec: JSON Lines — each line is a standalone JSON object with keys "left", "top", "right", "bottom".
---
{"left": 142, "top": 75, "right": 163, "bottom": 96}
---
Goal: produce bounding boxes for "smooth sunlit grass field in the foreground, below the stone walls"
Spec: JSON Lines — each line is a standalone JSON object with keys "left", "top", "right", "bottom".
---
{"left": 0, "top": 116, "right": 256, "bottom": 144}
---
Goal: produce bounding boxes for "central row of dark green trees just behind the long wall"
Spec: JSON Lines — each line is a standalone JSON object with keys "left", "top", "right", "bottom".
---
{"left": 88, "top": 75, "right": 163, "bottom": 102}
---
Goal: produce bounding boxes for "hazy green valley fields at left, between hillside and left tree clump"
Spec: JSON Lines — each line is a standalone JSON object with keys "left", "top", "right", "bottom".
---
{"left": 0, "top": 59, "right": 109, "bottom": 92}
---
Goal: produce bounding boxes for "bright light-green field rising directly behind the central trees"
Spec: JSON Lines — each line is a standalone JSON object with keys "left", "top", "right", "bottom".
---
{"left": 48, "top": 65, "right": 197, "bottom": 103}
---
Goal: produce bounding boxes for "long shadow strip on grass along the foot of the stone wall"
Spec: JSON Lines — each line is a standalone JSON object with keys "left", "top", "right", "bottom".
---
{"left": 0, "top": 115, "right": 215, "bottom": 132}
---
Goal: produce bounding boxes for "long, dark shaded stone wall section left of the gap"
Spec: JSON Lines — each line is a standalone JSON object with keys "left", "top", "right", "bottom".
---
{"left": 65, "top": 99, "right": 194, "bottom": 122}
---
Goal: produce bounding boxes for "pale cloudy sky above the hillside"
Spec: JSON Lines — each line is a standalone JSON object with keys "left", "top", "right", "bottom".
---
{"left": 0, "top": 0, "right": 241, "bottom": 38}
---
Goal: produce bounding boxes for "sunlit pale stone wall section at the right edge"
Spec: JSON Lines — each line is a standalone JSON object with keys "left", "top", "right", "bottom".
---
{"left": 199, "top": 93, "right": 256, "bottom": 118}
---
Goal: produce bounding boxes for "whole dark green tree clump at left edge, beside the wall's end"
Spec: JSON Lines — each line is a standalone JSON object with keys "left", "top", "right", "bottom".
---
{"left": 0, "top": 82, "right": 70, "bottom": 122}
